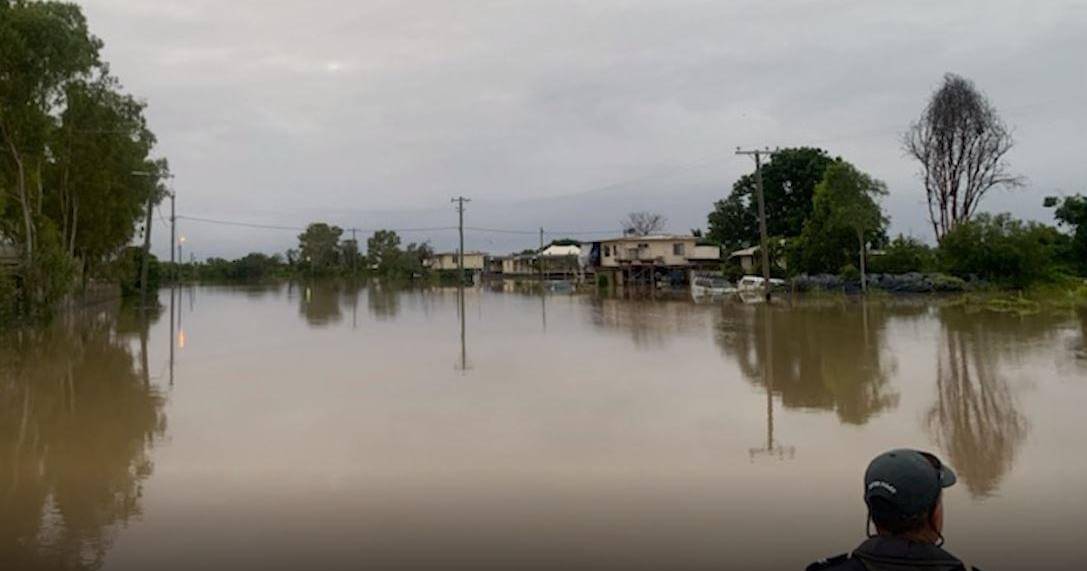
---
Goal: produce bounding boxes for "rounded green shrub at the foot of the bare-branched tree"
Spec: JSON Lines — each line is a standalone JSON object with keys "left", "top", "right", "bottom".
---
{"left": 939, "top": 210, "right": 1070, "bottom": 287}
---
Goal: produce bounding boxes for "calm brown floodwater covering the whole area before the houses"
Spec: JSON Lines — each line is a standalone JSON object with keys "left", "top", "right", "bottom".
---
{"left": 0, "top": 283, "right": 1087, "bottom": 570}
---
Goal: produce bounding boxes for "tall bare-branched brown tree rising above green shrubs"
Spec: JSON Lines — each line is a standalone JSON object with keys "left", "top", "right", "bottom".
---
{"left": 903, "top": 73, "right": 1022, "bottom": 241}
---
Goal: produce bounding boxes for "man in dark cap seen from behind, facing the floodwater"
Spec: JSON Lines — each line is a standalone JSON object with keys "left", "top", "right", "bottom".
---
{"left": 808, "top": 449, "right": 966, "bottom": 571}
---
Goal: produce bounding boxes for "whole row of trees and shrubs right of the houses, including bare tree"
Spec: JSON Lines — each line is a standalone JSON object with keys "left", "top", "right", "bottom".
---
{"left": 707, "top": 75, "right": 1087, "bottom": 287}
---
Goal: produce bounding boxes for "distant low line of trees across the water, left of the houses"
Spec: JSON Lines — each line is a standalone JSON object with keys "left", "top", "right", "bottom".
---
{"left": 162, "top": 222, "right": 434, "bottom": 282}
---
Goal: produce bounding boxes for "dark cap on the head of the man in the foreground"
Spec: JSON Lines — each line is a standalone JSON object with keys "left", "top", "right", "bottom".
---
{"left": 864, "top": 448, "right": 958, "bottom": 517}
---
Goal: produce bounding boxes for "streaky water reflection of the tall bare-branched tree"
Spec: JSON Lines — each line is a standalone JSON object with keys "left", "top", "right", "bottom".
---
{"left": 927, "top": 308, "right": 1026, "bottom": 497}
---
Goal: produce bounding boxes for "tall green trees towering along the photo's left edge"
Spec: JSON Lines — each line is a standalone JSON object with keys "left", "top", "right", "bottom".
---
{"left": 0, "top": 0, "right": 167, "bottom": 318}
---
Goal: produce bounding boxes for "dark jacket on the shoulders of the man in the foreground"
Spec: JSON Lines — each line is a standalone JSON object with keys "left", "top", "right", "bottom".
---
{"left": 808, "top": 537, "right": 977, "bottom": 571}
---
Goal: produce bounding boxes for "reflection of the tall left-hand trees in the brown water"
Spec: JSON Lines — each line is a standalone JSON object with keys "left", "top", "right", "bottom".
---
{"left": 0, "top": 304, "right": 166, "bottom": 569}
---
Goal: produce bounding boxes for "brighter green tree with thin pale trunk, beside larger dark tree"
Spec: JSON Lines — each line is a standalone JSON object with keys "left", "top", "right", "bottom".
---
{"left": 814, "top": 161, "right": 887, "bottom": 293}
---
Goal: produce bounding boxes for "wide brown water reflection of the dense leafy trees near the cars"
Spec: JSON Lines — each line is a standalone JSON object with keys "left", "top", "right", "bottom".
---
{"left": 715, "top": 303, "right": 898, "bottom": 424}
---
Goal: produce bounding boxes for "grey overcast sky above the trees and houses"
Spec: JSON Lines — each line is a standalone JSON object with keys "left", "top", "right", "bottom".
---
{"left": 84, "top": 0, "right": 1087, "bottom": 256}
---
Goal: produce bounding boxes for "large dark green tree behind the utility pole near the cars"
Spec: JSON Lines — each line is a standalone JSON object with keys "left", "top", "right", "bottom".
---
{"left": 707, "top": 147, "right": 834, "bottom": 250}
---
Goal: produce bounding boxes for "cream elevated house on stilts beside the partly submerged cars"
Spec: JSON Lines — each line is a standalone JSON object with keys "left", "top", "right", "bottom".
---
{"left": 590, "top": 234, "right": 721, "bottom": 286}
